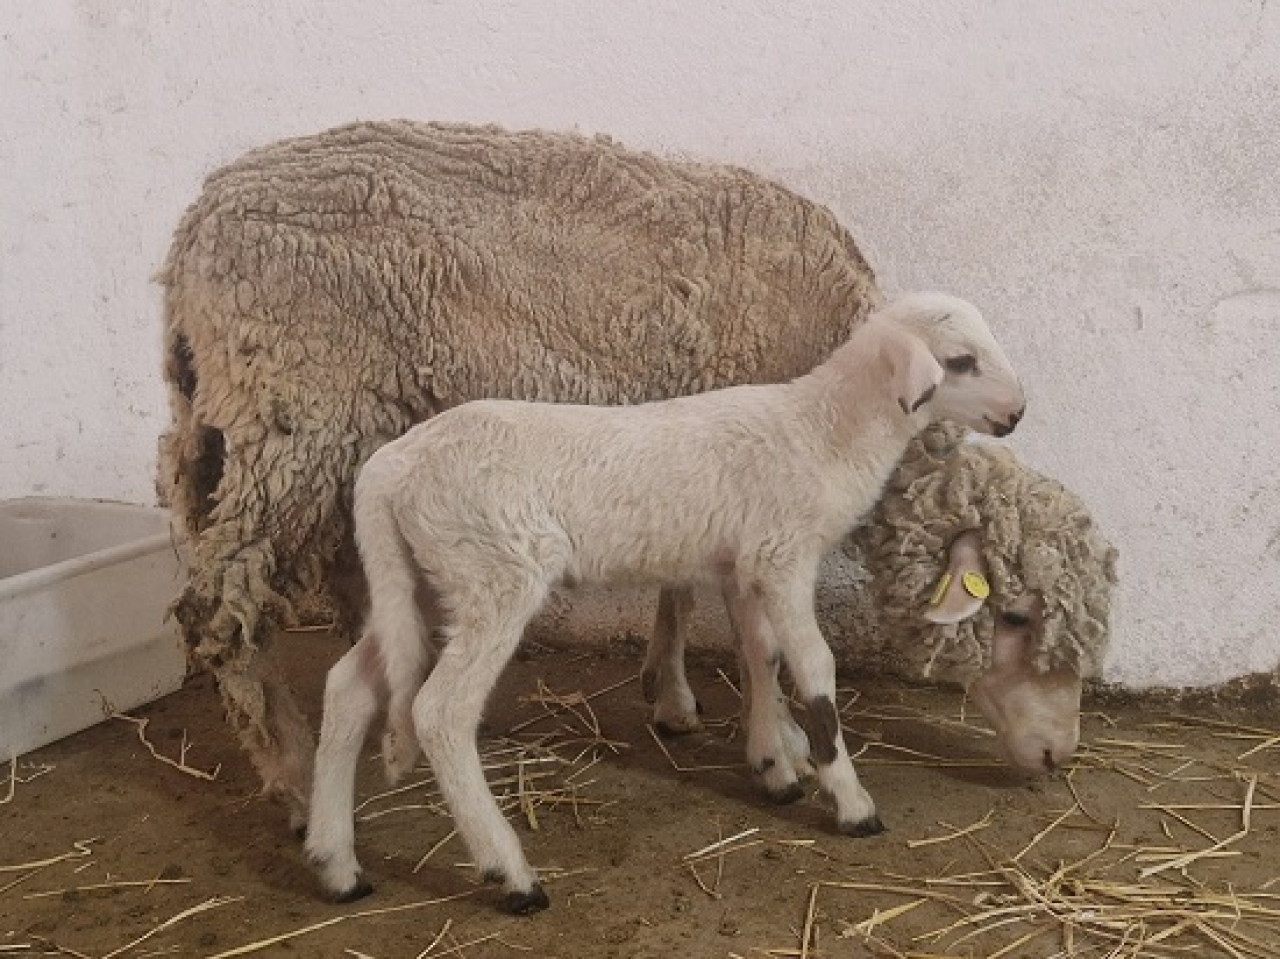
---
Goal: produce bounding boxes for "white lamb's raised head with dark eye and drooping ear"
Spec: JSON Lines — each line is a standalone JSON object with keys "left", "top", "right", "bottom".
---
{"left": 869, "top": 293, "right": 1027, "bottom": 437}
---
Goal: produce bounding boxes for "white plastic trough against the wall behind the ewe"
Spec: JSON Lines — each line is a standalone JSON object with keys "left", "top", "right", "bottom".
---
{"left": 0, "top": 498, "right": 186, "bottom": 762}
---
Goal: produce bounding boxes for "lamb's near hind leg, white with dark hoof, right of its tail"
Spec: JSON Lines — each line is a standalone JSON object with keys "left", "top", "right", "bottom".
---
{"left": 413, "top": 591, "right": 549, "bottom": 915}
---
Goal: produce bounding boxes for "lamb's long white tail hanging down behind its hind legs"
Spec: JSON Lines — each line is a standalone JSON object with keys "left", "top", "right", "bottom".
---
{"left": 355, "top": 461, "right": 430, "bottom": 784}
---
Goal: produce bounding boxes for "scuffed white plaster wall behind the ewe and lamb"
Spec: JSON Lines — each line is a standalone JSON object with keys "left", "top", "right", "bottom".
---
{"left": 0, "top": 0, "right": 1280, "bottom": 685}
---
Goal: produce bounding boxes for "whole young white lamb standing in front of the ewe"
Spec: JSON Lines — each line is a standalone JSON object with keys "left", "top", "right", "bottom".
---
{"left": 307, "top": 294, "right": 1024, "bottom": 914}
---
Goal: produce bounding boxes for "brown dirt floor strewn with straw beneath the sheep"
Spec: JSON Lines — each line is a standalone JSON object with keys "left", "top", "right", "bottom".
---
{"left": 0, "top": 636, "right": 1280, "bottom": 959}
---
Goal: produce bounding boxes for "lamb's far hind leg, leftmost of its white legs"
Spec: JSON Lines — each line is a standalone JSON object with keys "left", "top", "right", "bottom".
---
{"left": 306, "top": 634, "right": 384, "bottom": 903}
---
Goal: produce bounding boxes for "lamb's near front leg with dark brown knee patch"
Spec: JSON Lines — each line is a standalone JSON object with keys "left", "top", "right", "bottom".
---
{"left": 763, "top": 579, "right": 884, "bottom": 836}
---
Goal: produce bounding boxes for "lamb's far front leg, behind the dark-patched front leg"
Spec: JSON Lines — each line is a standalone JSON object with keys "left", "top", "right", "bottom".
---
{"left": 722, "top": 581, "right": 804, "bottom": 803}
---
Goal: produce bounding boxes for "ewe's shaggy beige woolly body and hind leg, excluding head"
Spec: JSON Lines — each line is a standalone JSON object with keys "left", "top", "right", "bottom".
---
{"left": 157, "top": 122, "right": 881, "bottom": 826}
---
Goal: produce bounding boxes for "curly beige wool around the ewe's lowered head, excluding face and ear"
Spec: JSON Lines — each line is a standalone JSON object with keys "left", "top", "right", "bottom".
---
{"left": 851, "top": 424, "right": 1116, "bottom": 682}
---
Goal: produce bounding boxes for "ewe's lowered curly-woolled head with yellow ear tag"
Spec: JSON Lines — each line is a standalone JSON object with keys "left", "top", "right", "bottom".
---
{"left": 855, "top": 424, "right": 1116, "bottom": 772}
